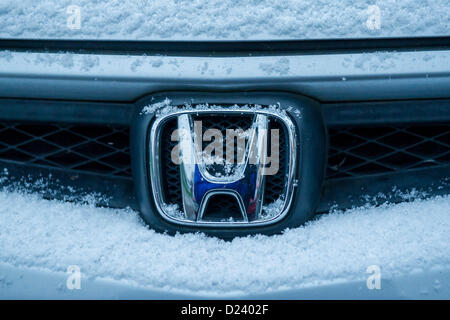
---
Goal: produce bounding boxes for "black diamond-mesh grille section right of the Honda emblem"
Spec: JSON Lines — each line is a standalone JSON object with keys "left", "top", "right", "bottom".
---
{"left": 327, "top": 123, "right": 450, "bottom": 179}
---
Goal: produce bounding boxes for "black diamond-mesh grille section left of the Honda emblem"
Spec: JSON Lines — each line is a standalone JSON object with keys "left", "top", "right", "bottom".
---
{"left": 0, "top": 122, "right": 131, "bottom": 177}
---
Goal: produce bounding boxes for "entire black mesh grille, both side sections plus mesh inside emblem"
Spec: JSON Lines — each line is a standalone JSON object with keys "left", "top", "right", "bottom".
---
{"left": 0, "top": 117, "right": 450, "bottom": 212}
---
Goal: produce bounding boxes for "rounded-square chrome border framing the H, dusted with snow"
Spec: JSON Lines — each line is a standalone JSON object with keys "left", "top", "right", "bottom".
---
{"left": 148, "top": 105, "right": 298, "bottom": 227}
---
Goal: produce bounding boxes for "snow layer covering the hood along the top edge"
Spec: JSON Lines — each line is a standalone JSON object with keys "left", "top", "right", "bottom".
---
{"left": 0, "top": 0, "right": 450, "bottom": 40}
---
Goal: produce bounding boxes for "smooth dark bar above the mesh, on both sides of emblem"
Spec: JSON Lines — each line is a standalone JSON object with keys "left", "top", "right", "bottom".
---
{"left": 0, "top": 99, "right": 450, "bottom": 126}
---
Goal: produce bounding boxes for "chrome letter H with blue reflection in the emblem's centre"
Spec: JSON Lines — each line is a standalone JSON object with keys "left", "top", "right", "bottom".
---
{"left": 175, "top": 114, "right": 272, "bottom": 222}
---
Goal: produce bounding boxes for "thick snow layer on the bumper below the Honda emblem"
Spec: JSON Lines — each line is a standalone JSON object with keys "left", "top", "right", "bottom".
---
{"left": 0, "top": 190, "right": 450, "bottom": 297}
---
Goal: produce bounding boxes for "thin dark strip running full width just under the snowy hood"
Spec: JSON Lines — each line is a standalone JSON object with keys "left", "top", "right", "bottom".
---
{"left": 0, "top": 36, "right": 450, "bottom": 57}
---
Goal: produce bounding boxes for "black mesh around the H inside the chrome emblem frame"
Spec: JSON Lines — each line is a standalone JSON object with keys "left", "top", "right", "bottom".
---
{"left": 161, "top": 115, "right": 288, "bottom": 212}
